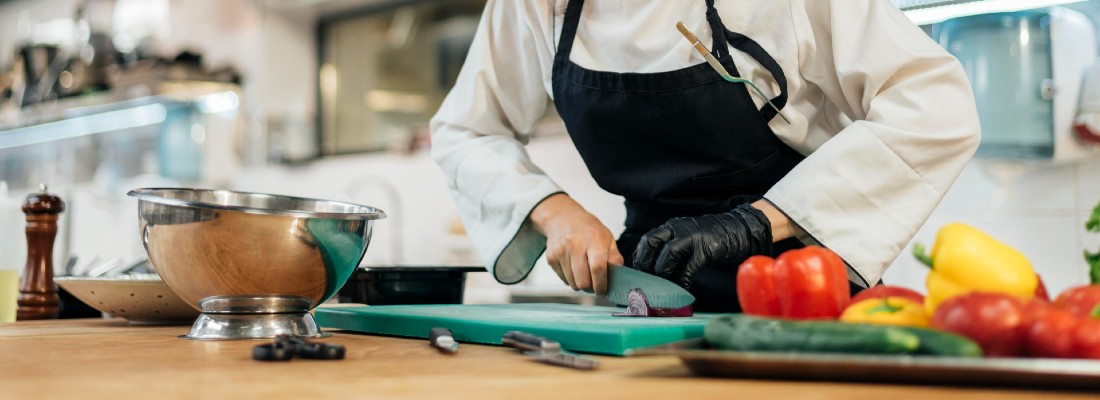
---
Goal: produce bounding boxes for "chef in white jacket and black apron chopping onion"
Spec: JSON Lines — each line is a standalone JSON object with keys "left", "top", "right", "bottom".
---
{"left": 431, "top": 0, "right": 979, "bottom": 311}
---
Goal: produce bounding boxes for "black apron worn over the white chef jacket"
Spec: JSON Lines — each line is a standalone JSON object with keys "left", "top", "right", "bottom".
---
{"left": 552, "top": 0, "right": 804, "bottom": 312}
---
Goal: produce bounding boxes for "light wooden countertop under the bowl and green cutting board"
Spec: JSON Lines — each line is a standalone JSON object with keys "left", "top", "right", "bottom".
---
{"left": 0, "top": 320, "right": 1097, "bottom": 400}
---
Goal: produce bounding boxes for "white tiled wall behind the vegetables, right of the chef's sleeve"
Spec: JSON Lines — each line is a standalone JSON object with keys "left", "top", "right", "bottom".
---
{"left": 883, "top": 159, "right": 1100, "bottom": 293}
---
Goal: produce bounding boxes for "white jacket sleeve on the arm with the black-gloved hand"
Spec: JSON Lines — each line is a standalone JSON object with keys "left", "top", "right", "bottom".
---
{"left": 765, "top": 0, "right": 980, "bottom": 284}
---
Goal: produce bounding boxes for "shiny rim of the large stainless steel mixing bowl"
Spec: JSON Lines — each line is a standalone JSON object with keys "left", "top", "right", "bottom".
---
{"left": 127, "top": 188, "right": 386, "bottom": 220}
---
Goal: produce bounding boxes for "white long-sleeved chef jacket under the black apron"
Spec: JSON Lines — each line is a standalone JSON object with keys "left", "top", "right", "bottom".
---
{"left": 431, "top": 0, "right": 980, "bottom": 285}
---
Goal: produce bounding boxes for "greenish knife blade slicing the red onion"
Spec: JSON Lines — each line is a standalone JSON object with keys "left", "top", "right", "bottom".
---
{"left": 607, "top": 264, "right": 695, "bottom": 309}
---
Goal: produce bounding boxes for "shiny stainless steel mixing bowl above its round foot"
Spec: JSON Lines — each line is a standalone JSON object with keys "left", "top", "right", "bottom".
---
{"left": 128, "top": 188, "right": 386, "bottom": 335}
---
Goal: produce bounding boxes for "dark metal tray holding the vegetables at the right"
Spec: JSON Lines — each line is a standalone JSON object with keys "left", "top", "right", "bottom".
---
{"left": 627, "top": 338, "right": 1100, "bottom": 391}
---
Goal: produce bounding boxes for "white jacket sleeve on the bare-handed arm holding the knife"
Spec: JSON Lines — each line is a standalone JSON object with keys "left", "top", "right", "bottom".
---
{"left": 431, "top": 0, "right": 561, "bottom": 284}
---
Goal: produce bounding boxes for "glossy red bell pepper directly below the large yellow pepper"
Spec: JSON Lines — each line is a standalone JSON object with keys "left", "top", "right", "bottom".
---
{"left": 932, "top": 292, "right": 1031, "bottom": 357}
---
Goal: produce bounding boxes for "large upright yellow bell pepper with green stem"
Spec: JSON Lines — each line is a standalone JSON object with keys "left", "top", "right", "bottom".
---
{"left": 913, "top": 223, "right": 1038, "bottom": 314}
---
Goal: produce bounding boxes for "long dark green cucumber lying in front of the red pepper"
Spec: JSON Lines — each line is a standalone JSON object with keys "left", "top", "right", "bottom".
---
{"left": 703, "top": 314, "right": 921, "bottom": 354}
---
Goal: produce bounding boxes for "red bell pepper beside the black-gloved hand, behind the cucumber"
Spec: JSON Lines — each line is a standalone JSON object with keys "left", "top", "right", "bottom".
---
{"left": 737, "top": 246, "right": 850, "bottom": 319}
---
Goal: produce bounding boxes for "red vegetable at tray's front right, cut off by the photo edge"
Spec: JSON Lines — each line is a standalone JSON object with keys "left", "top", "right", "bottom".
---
{"left": 1027, "top": 304, "right": 1100, "bottom": 359}
